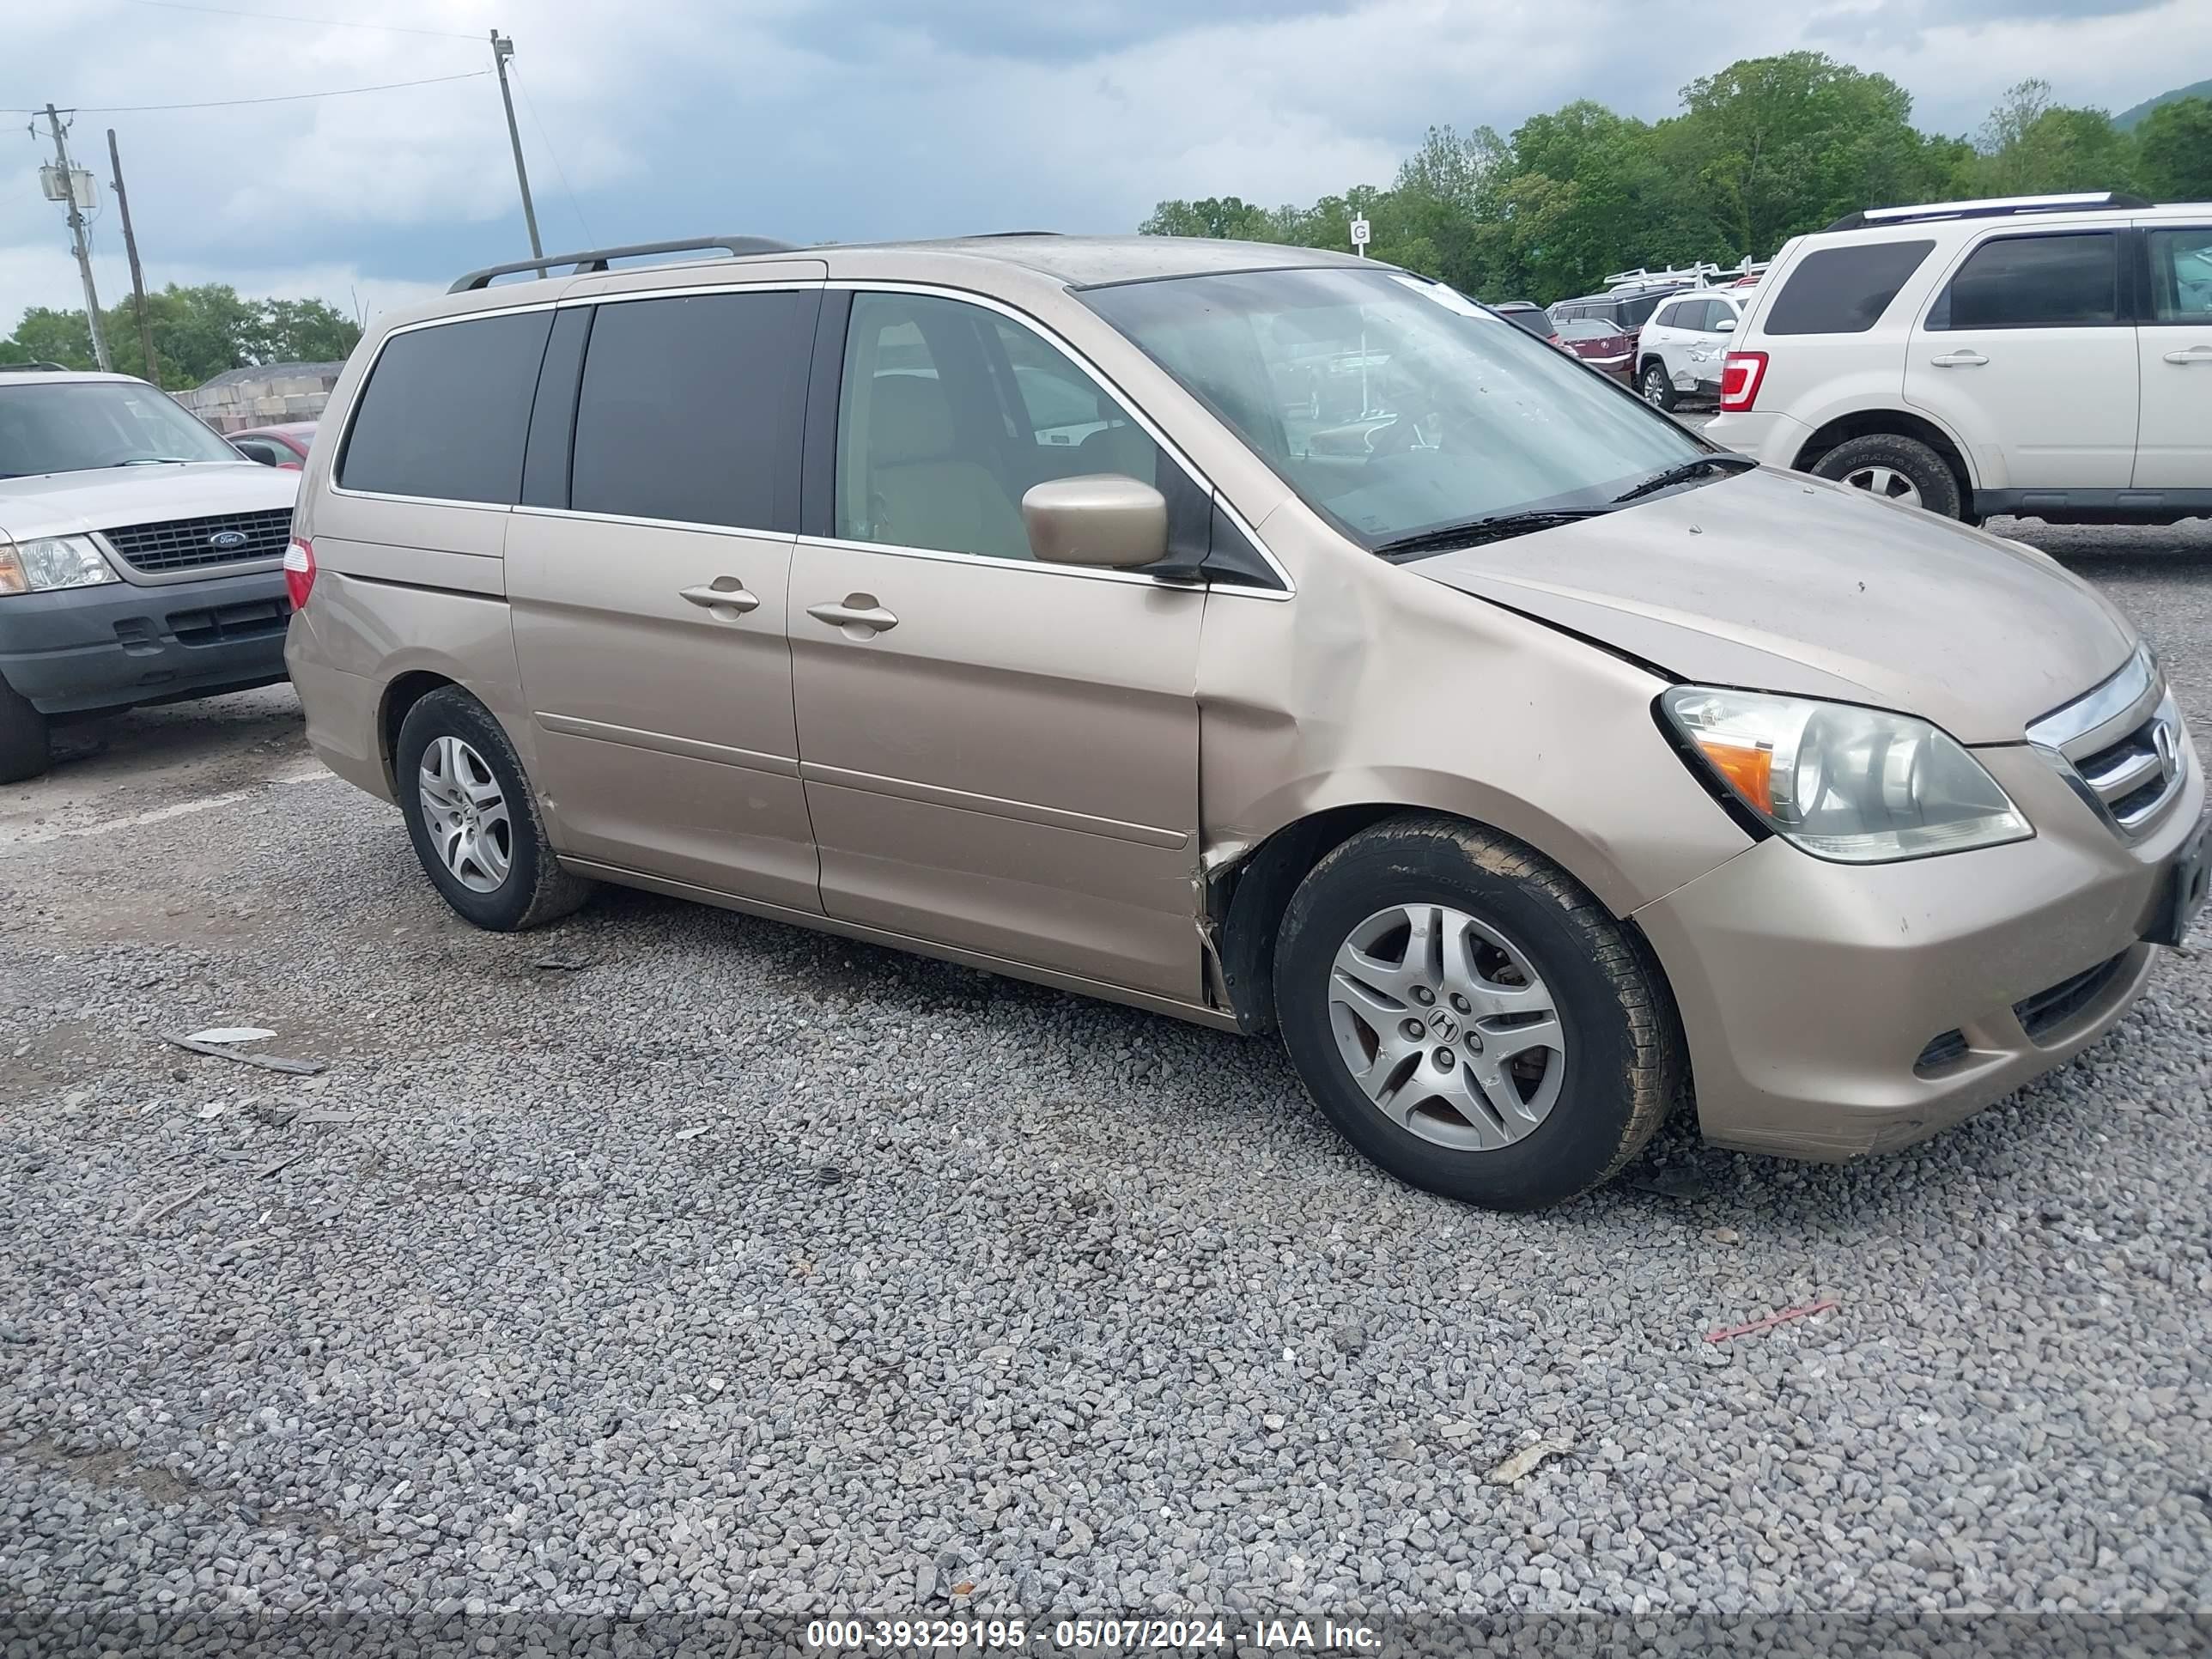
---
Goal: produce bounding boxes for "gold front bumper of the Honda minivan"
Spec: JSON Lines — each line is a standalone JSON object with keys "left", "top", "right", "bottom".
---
{"left": 1635, "top": 745, "right": 2205, "bottom": 1159}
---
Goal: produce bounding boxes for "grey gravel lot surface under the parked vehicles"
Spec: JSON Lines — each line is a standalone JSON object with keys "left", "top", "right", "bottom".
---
{"left": 0, "top": 522, "right": 2212, "bottom": 1652}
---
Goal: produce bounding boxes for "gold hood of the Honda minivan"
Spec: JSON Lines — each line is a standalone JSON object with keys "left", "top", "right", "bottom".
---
{"left": 1405, "top": 467, "right": 2135, "bottom": 744}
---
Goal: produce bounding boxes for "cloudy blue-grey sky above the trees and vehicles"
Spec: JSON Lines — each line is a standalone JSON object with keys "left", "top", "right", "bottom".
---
{"left": 0, "top": 0, "right": 2212, "bottom": 343}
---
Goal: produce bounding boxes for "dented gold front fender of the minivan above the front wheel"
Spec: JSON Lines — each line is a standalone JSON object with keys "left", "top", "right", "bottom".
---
{"left": 1199, "top": 502, "right": 1750, "bottom": 915}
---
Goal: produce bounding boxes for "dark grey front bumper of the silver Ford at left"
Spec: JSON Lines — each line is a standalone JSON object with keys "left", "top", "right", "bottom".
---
{"left": 0, "top": 571, "right": 292, "bottom": 714}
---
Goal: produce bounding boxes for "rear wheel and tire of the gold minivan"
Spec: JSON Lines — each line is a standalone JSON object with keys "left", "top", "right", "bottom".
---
{"left": 392, "top": 686, "right": 592, "bottom": 933}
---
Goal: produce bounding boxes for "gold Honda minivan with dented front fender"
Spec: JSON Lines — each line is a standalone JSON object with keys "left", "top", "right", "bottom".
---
{"left": 285, "top": 234, "right": 2205, "bottom": 1207}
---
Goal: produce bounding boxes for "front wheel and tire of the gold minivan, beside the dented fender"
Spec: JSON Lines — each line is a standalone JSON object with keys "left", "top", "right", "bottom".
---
{"left": 1274, "top": 814, "right": 1687, "bottom": 1210}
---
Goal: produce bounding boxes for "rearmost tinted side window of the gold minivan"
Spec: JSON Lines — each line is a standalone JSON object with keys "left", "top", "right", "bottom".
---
{"left": 338, "top": 312, "right": 553, "bottom": 507}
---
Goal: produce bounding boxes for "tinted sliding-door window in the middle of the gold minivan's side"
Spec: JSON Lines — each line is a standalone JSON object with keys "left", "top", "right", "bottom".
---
{"left": 568, "top": 289, "right": 821, "bottom": 531}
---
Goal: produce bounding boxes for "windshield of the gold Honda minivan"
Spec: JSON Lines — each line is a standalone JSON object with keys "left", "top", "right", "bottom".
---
{"left": 1082, "top": 268, "right": 1710, "bottom": 549}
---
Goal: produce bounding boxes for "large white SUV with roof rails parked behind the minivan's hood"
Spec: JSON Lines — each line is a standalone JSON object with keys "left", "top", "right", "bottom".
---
{"left": 1707, "top": 192, "right": 2212, "bottom": 525}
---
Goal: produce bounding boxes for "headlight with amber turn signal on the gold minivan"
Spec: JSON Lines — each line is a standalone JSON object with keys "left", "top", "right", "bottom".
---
{"left": 1659, "top": 686, "right": 2035, "bottom": 865}
